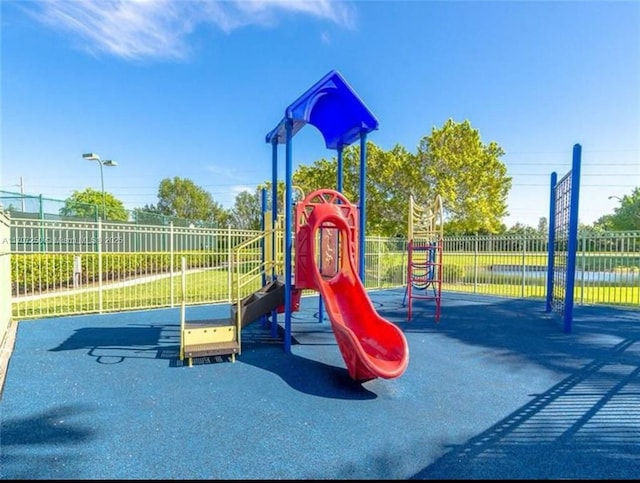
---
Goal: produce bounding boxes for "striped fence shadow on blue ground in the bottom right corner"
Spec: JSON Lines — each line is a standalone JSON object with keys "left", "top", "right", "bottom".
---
{"left": 412, "top": 356, "right": 640, "bottom": 479}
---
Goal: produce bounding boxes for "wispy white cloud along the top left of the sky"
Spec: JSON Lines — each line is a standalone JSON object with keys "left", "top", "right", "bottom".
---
{"left": 23, "top": 0, "right": 354, "bottom": 59}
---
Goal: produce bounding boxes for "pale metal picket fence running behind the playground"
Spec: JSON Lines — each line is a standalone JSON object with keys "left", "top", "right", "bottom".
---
{"left": 9, "top": 219, "right": 640, "bottom": 319}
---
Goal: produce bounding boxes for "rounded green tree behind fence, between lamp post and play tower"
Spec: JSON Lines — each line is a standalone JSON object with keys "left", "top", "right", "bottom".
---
{"left": 156, "top": 176, "right": 230, "bottom": 226}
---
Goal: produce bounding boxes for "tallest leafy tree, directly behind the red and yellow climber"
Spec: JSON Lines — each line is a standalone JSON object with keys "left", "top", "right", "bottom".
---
{"left": 416, "top": 119, "right": 511, "bottom": 235}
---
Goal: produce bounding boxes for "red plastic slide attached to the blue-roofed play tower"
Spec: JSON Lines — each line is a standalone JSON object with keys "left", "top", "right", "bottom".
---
{"left": 308, "top": 203, "right": 409, "bottom": 381}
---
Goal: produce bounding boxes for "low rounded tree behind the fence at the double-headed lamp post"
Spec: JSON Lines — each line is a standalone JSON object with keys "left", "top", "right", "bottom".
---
{"left": 59, "top": 188, "right": 129, "bottom": 221}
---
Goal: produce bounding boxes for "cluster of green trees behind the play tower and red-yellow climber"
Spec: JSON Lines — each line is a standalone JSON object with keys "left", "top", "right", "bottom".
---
{"left": 293, "top": 120, "right": 511, "bottom": 236}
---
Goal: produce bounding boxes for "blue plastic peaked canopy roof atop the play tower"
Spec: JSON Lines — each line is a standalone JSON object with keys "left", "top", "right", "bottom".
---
{"left": 266, "top": 70, "right": 378, "bottom": 149}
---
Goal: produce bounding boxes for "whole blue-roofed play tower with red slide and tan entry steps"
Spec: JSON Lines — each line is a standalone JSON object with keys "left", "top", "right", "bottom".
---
{"left": 180, "top": 71, "right": 409, "bottom": 381}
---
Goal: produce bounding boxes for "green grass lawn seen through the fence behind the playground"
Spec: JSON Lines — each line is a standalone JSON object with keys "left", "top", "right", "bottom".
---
{"left": 13, "top": 253, "right": 640, "bottom": 319}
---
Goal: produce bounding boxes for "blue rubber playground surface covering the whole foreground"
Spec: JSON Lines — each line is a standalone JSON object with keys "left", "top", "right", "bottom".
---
{"left": 0, "top": 289, "right": 640, "bottom": 479}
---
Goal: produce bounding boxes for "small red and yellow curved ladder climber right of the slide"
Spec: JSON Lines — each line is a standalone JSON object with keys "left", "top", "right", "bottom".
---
{"left": 402, "top": 195, "right": 444, "bottom": 322}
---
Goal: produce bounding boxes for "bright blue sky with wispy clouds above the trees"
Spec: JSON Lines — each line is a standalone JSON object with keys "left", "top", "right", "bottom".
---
{"left": 0, "top": 0, "right": 640, "bottom": 227}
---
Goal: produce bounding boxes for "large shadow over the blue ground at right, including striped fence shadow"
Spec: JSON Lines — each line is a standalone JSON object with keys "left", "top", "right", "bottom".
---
{"left": 384, "top": 295, "right": 640, "bottom": 479}
